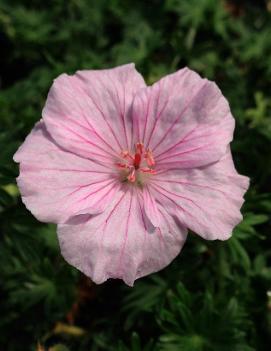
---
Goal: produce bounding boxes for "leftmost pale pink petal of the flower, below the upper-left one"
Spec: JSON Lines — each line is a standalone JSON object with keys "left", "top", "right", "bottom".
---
{"left": 14, "top": 122, "right": 119, "bottom": 222}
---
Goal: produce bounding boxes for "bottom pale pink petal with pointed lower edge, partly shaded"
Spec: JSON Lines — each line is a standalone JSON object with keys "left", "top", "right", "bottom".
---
{"left": 58, "top": 185, "right": 186, "bottom": 286}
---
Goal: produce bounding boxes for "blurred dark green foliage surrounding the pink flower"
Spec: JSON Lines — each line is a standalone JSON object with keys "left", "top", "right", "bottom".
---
{"left": 0, "top": 0, "right": 271, "bottom": 351}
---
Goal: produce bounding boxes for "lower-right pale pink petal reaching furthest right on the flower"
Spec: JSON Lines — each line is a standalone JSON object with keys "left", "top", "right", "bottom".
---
{"left": 151, "top": 151, "right": 249, "bottom": 240}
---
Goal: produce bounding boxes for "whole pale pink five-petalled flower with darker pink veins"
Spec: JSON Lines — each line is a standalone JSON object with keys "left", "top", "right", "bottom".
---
{"left": 14, "top": 64, "right": 248, "bottom": 285}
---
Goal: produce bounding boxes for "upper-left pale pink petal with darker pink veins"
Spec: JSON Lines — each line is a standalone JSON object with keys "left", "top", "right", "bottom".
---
{"left": 42, "top": 64, "right": 145, "bottom": 160}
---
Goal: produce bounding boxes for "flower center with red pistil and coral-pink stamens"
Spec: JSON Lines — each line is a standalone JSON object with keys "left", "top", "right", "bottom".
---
{"left": 117, "top": 143, "right": 155, "bottom": 185}
